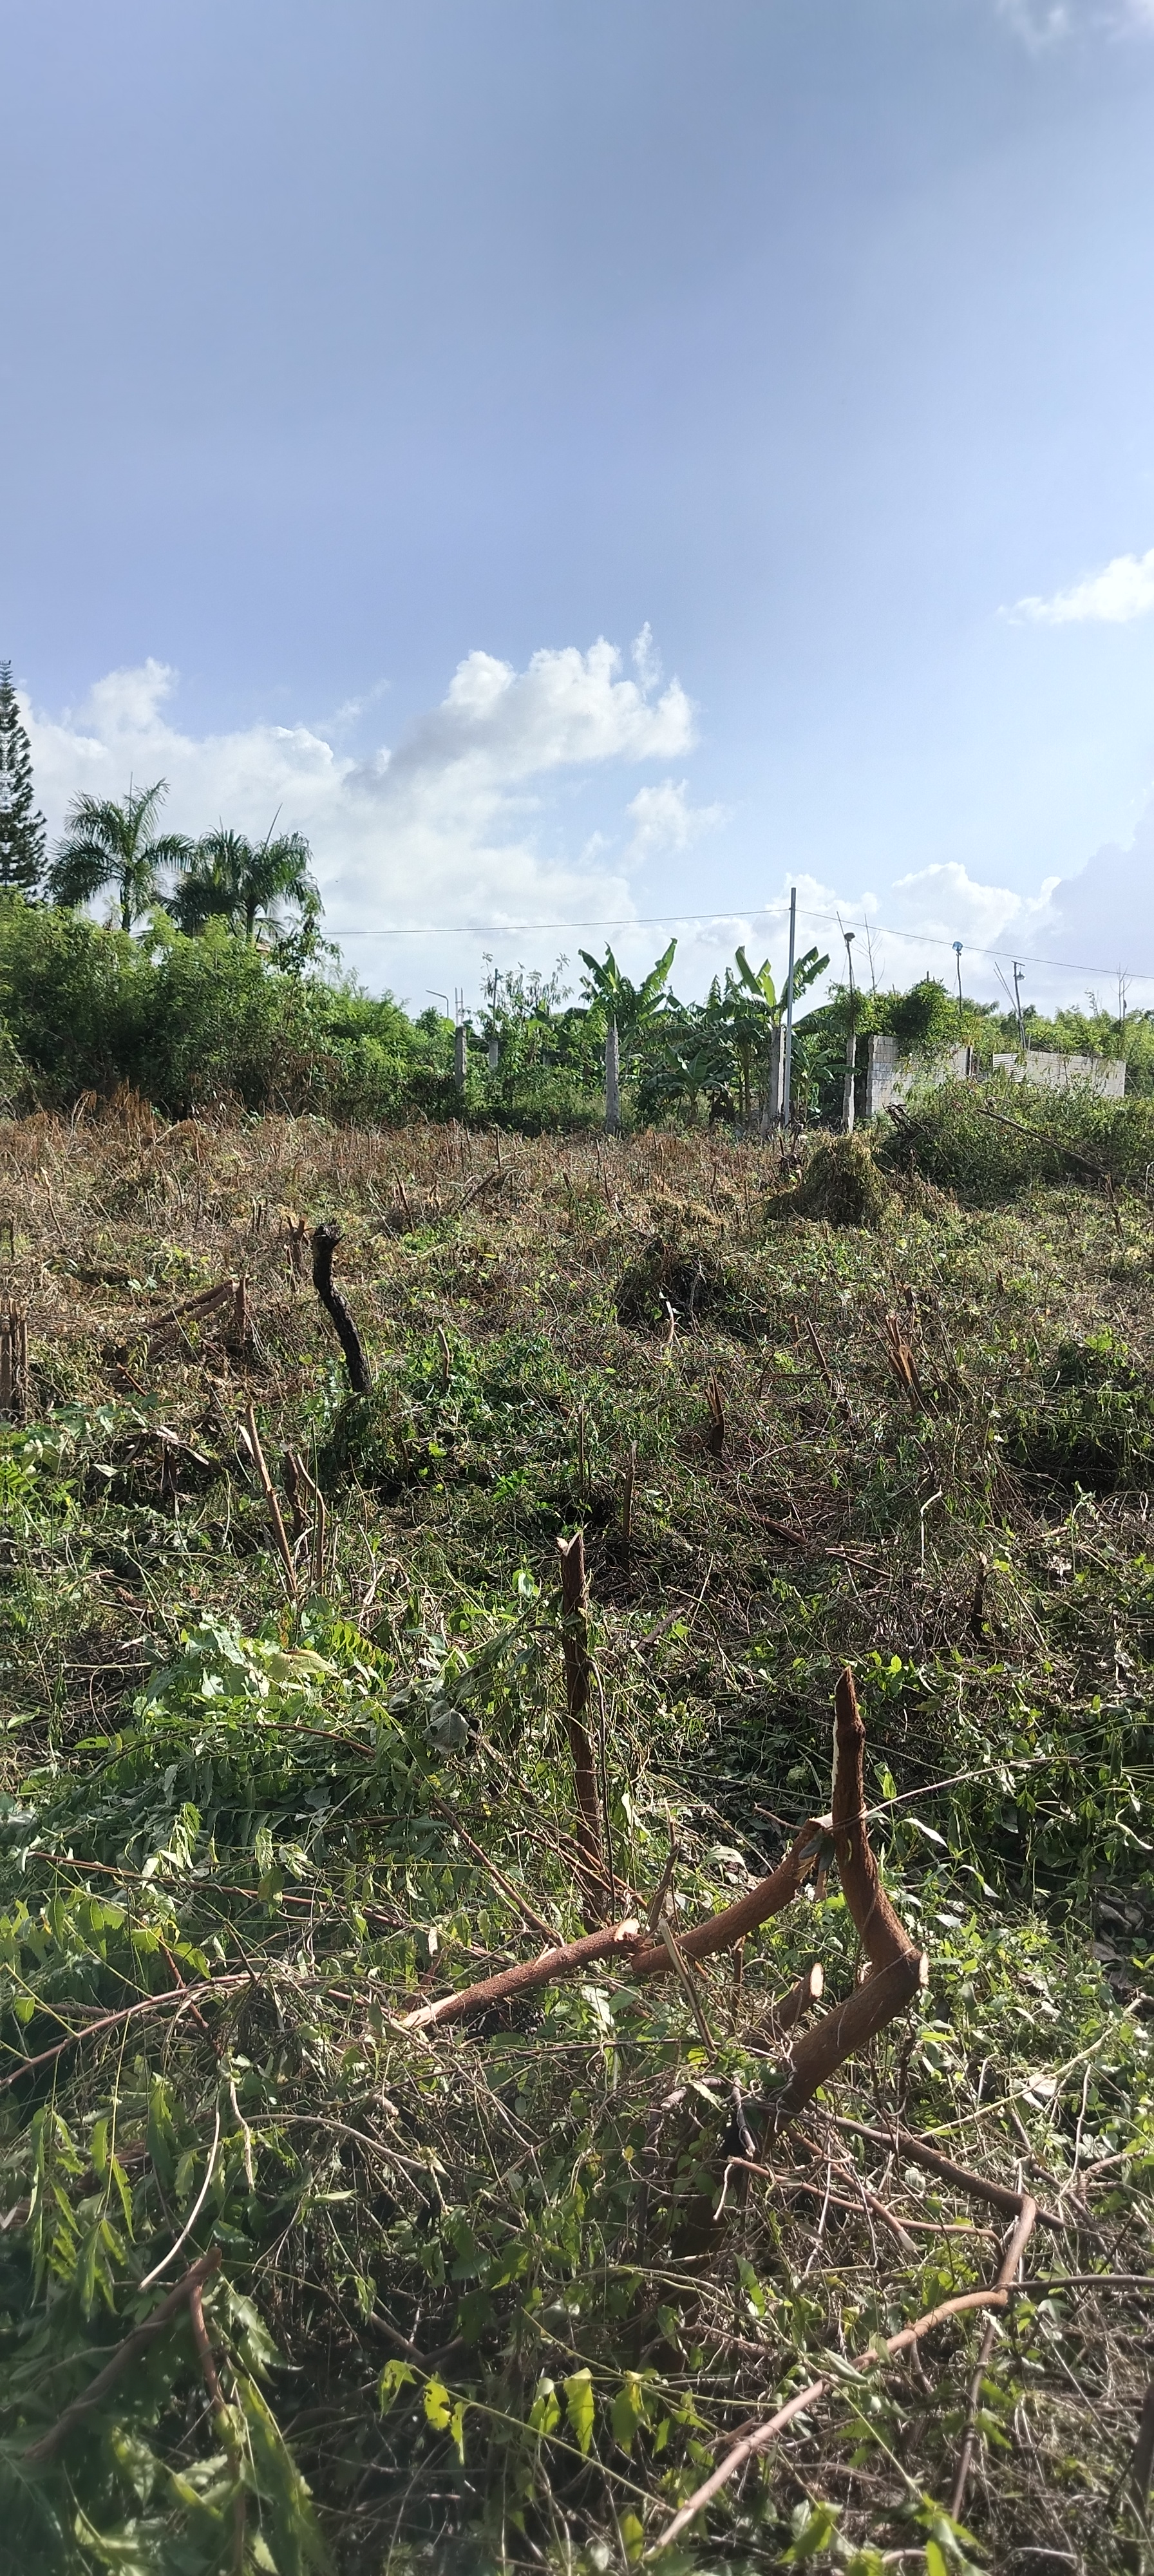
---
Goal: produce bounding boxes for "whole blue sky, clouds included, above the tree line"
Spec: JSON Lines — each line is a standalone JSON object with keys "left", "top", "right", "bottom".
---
{"left": 0, "top": 0, "right": 1154, "bottom": 1007}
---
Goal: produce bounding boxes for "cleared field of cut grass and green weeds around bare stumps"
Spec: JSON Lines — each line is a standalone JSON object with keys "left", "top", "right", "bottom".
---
{"left": 0, "top": 1097, "right": 1154, "bottom": 2576}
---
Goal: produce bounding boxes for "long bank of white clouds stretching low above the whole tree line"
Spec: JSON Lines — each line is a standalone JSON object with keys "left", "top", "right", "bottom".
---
{"left": 28, "top": 644, "right": 1154, "bottom": 1007}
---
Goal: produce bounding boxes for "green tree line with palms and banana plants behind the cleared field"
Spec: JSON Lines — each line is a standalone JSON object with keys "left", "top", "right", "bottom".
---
{"left": 0, "top": 665, "right": 1154, "bottom": 1131}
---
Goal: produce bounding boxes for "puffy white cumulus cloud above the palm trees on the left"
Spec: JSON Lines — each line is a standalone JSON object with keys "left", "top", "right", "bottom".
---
{"left": 28, "top": 634, "right": 695, "bottom": 979}
